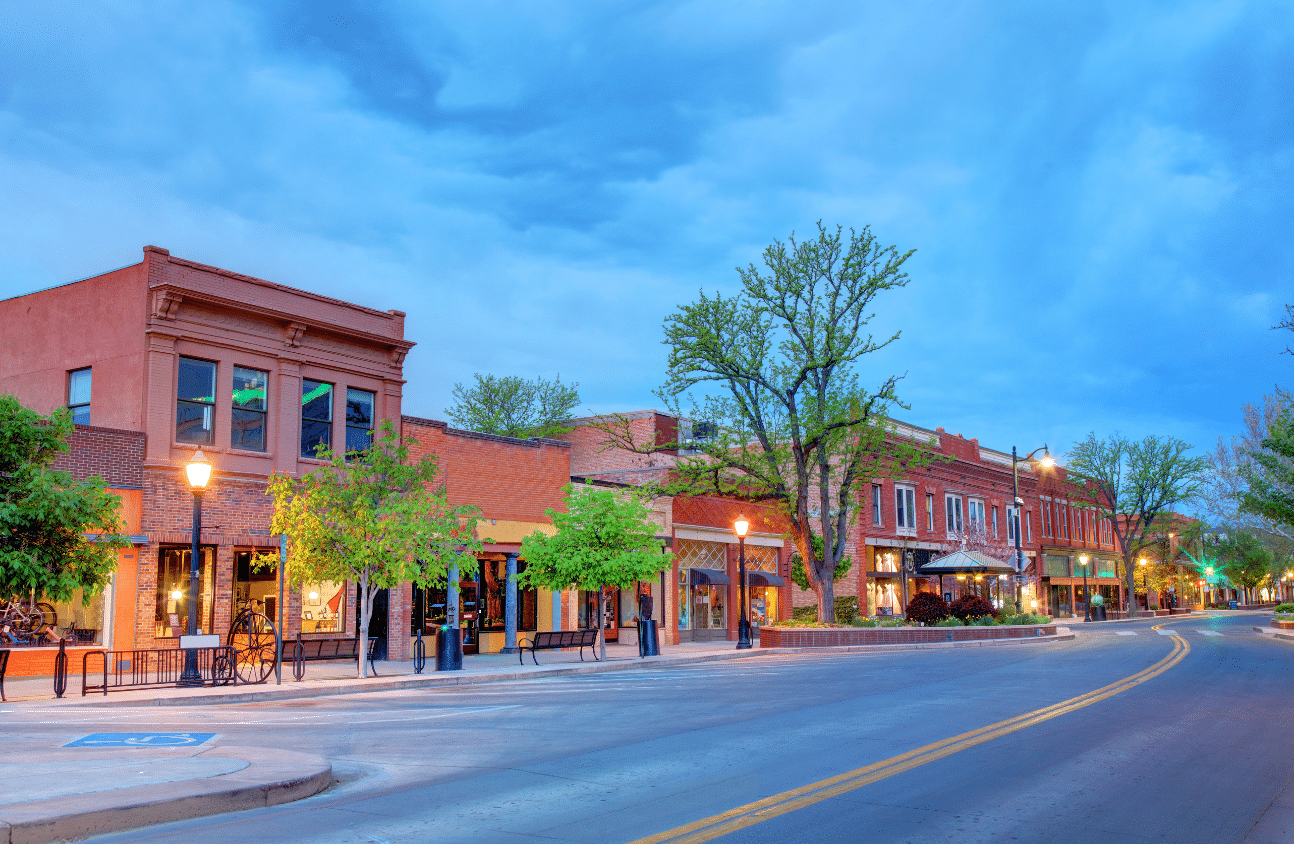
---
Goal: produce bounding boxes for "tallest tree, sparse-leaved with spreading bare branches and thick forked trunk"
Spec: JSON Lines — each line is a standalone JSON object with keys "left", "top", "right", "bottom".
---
{"left": 592, "top": 222, "right": 932, "bottom": 622}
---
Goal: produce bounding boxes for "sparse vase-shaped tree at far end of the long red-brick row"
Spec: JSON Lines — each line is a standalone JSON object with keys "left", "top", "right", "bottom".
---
{"left": 1066, "top": 432, "right": 1209, "bottom": 613}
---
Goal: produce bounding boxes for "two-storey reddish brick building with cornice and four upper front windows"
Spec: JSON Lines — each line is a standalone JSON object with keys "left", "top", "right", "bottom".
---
{"left": 0, "top": 247, "right": 413, "bottom": 667}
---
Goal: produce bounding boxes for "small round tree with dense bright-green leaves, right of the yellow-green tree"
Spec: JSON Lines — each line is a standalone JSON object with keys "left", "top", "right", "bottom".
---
{"left": 516, "top": 484, "right": 674, "bottom": 658}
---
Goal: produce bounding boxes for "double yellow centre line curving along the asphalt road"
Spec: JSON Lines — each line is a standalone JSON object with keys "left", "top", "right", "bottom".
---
{"left": 634, "top": 624, "right": 1190, "bottom": 843}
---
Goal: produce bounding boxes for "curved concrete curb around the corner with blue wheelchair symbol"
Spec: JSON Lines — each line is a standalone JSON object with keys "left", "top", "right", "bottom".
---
{"left": 0, "top": 746, "right": 333, "bottom": 843}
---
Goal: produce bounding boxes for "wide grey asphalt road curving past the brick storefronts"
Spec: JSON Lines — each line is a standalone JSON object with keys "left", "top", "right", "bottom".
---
{"left": 0, "top": 614, "right": 1294, "bottom": 842}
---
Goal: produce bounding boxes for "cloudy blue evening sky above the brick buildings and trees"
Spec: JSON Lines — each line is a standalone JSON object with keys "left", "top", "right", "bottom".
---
{"left": 0, "top": 0, "right": 1294, "bottom": 463}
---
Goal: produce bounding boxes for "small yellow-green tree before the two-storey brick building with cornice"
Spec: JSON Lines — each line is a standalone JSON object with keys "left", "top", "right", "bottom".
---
{"left": 269, "top": 420, "right": 481, "bottom": 678}
